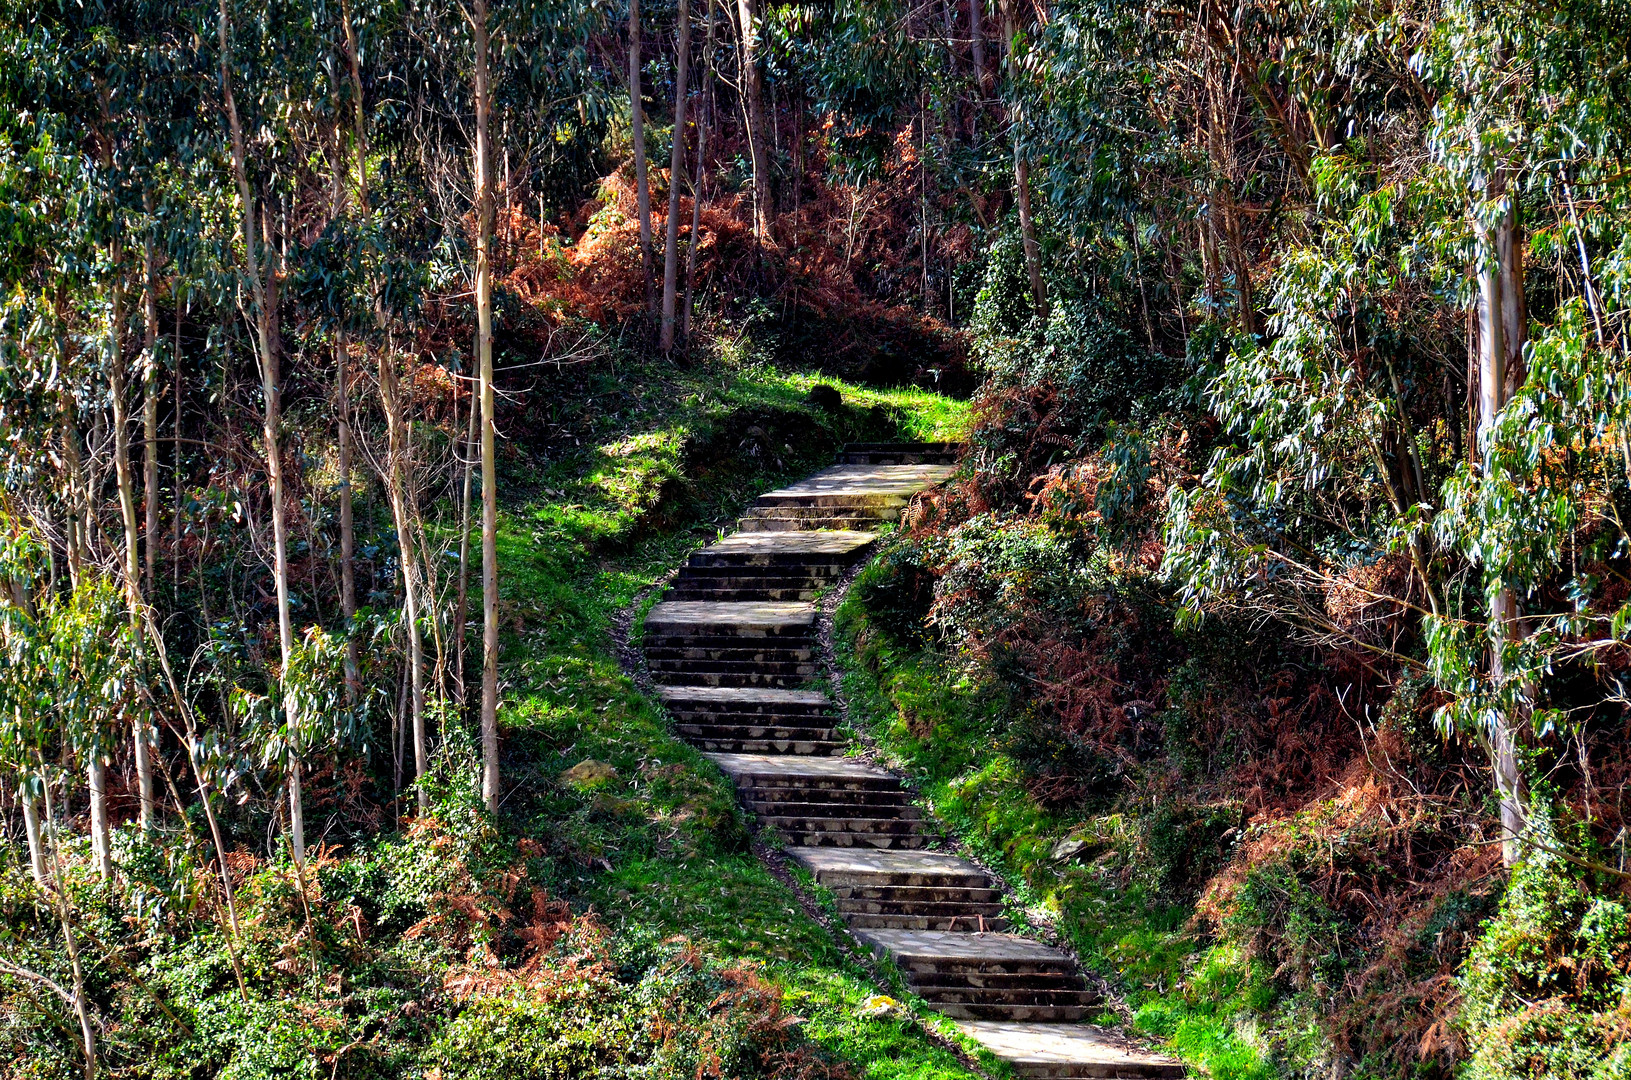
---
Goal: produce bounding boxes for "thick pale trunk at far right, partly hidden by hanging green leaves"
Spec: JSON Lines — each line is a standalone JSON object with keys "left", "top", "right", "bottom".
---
{"left": 1478, "top": 176, "right": 1528, "bottom": 866}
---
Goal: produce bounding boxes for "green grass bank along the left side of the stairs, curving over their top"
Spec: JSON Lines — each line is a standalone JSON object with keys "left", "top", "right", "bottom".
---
{"left": 472, "top": 354, "right": 970, "bottom": 1080}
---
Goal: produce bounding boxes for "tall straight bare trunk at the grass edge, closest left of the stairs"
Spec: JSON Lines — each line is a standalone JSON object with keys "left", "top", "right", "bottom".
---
{"left": 475, "top": 0, "right": 495, "bottom": 814}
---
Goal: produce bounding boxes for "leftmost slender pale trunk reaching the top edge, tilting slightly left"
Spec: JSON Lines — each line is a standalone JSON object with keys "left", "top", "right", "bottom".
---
{"left": 217, "top": 0, "right": 305, "bottom": 866}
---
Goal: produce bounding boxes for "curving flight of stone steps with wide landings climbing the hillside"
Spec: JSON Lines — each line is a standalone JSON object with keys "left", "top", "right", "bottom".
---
{"left": 644, "top": 444, "right": 1184, "bottom": 1080}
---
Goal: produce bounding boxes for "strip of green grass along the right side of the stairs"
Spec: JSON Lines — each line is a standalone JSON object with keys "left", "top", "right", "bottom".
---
{"left": 837, "top": 560, "right": 1279, "bottom": 1080}
